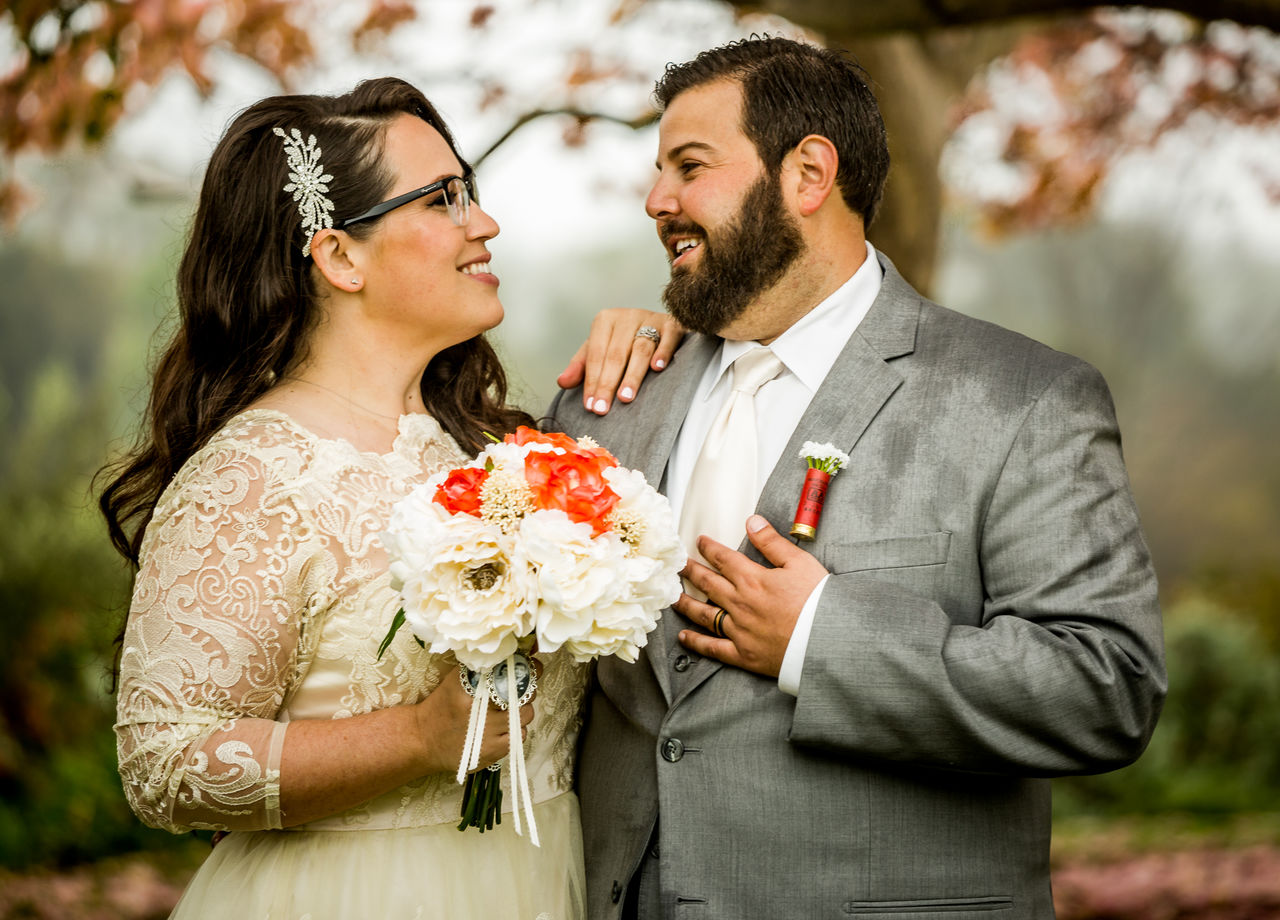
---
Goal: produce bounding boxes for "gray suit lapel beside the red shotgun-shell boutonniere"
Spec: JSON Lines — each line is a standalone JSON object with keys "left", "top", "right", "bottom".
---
{"left": 670, "top": 256, "right": 922, "bottom": 702}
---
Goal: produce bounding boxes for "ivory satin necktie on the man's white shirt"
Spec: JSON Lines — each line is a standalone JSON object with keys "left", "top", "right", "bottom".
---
{"left": 680, "top": 347, "right": 782, "bottom": 573}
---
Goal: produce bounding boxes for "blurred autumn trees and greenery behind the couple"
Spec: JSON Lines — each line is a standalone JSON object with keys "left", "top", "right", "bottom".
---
{"left": 0, "top": 0, "right": 1280, "bottom": 919}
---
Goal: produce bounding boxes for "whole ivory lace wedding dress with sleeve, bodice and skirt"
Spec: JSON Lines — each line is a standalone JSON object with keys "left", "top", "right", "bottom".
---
{"left": 116, "top": 409, "right": 586, "bottom": 920}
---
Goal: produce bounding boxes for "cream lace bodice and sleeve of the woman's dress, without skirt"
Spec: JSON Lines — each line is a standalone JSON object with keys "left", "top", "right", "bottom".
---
{"left": 116, "top": 409, "right": 586, "bottom": 832}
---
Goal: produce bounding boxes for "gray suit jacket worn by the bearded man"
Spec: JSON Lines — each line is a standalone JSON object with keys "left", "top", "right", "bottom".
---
{"left": 552, "top": 258, "right": 1166, "bottom": 920}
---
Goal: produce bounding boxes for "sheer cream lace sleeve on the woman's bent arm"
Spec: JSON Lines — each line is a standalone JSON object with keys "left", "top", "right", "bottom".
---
{"left": 115, "top": 443, "right": 334, "bottom": 832}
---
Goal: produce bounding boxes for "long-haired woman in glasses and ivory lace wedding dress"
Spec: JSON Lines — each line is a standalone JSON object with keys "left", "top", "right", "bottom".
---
{"left": 101, "top": 79, "right": 678, "bottom": 920}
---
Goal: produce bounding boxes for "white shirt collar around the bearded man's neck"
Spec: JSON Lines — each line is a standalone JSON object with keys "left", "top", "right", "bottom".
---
{"left": 708, "top": 243, "right": 884, "bottom": 395}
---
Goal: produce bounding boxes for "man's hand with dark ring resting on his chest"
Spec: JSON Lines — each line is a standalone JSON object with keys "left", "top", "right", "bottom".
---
{"left": 675, "top": 514, "right": 827, "bottom": 677}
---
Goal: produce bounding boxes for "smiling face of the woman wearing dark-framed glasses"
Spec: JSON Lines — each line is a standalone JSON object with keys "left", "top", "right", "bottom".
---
{"left": 361, "top": 115, "right": 502, "bottom": 351}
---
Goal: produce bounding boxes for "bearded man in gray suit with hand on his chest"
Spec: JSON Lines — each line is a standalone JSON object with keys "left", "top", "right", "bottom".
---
{"left": 553, "top": 38, "right": 1166, "bottom": 920}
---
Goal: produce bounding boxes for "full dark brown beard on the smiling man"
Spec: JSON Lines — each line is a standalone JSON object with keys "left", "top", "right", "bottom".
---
{"left": 662, "top": 175, "right": 804, "bottom": 335}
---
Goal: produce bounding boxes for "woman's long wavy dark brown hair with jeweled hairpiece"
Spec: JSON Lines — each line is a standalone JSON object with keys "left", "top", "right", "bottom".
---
{"left": 99, "top": 78, "right": 532, "bottom": 566}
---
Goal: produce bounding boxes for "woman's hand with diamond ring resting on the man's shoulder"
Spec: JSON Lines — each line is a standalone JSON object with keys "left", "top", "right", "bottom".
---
{"left": 556, "top": 307, "right": 685, "bottom": 416}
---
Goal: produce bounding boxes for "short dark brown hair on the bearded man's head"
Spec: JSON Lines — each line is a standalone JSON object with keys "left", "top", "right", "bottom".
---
{"left": 654, "top": 36, "right": 888, "bottom": 226}
